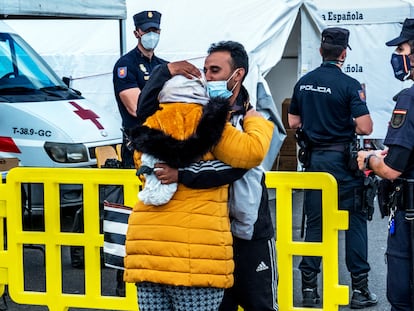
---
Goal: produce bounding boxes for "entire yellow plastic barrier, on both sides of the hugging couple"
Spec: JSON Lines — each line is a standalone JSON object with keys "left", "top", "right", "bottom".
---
{"left": 0, "top": 167, "right": 348, "bottom": 311}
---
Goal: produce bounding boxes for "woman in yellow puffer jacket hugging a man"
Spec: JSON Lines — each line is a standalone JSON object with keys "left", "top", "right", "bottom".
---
{"left": 124, "top": 72, "right": 273, "bottom": 311}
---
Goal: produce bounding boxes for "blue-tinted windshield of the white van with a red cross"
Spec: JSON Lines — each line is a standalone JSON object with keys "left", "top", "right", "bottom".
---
{"left": 0, "top": 33, "right": 79, "bottom": 102}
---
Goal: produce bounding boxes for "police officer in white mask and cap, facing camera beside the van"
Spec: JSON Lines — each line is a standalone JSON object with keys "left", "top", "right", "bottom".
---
{"left": 113, "top": 11, "right": 166, "bottom": 168}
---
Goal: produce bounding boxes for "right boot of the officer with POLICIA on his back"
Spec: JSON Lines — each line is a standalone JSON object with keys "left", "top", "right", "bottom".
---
{"left": 351, "top": 273, "right": 378, "bottom": 309}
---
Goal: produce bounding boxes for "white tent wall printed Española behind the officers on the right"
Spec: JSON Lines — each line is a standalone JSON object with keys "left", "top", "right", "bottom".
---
{"left": 299, "top": 0, "right": 414, "bottom": 138}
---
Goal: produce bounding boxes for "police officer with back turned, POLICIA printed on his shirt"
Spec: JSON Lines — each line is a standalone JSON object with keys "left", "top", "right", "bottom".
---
{"left": 288, "top": 27, "right": 377, "bottom": 309}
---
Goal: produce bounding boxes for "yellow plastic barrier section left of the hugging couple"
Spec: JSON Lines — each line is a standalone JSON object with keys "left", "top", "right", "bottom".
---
{"left": 0, "top": 168, "right": 139, "bottom": 311}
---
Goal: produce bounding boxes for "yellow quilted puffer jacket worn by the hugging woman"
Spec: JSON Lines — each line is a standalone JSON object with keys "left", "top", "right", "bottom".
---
{"left": 124, "top": 99, "right": 273, "bottom": 288}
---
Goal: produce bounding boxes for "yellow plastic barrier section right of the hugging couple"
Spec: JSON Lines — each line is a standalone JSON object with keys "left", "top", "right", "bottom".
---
{"left": 266, "top": 172, "right": 349, "bottom": 311}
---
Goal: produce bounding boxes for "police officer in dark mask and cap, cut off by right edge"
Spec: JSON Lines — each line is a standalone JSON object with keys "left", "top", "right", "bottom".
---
{"left": 358, "top": 19, "right": 414, "bottom": 311}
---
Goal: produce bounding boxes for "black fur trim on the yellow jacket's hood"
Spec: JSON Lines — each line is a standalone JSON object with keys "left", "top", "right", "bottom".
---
{"left": 130, "top": 98, "right": 230, "bottom": 168}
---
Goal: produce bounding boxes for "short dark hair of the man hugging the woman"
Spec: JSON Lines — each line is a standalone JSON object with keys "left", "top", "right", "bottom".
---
{"left": 207, "top": 41, "right": 249, "bottom": 80}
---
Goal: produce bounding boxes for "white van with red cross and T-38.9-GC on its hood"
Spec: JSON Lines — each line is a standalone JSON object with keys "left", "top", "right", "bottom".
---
{"left": 0, "top": 21, "right": 122, "bottom": 205}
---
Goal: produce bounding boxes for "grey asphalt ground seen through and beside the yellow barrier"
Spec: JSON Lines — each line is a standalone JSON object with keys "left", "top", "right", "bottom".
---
{"left": 0, "top": 192, "right": 390, "bottom": 311}
